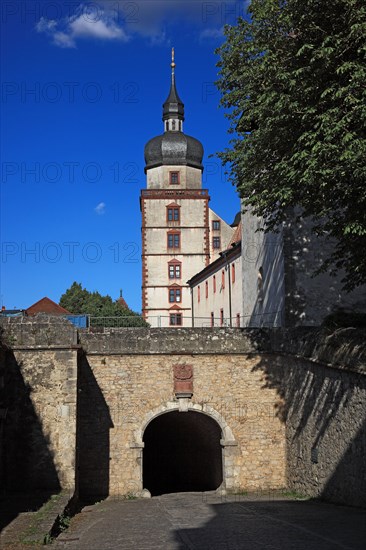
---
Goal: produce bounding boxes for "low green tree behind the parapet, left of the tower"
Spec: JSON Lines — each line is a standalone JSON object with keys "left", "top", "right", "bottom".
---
{"left": 60, "top": 282, "right": 148, "bottom": 326}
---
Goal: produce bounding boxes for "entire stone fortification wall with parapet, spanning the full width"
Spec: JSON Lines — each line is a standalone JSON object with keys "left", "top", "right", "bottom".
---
{"left": 0, "top": 317, "right": 366, "bottom": 505}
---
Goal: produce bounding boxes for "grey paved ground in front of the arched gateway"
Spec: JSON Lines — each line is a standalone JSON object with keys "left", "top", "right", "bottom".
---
{"left": 52, "top": 493, "right": 366, "bottom": 550}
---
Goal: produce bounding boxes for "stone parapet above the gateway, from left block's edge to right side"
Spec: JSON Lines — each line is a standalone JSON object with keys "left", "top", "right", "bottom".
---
{"left": 79, "top": 327, "right": 366, "bottom": 373}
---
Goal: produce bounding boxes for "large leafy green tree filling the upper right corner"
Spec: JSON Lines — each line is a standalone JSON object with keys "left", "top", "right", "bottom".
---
{"left": 217, "top": 0, "right": 366, "bottom": 290}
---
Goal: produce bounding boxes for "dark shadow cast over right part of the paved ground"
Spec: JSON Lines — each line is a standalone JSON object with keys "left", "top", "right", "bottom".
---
{"left": 174, "top": 497, "right": 366, "bottom": 550}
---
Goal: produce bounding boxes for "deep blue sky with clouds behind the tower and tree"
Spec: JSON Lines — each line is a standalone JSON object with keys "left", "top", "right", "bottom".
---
{"left": 0, "top": 0, "right": 245, "bottom": 311}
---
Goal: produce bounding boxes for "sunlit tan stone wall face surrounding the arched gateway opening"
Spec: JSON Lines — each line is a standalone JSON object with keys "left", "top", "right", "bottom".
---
{"left": 80, "top": 354, "right": 286, "bottom": 500}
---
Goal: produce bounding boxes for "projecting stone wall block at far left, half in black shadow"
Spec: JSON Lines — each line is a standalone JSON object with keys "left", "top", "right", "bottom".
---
{"left": 1, "top": 316, "right": 78, "bottom": 491}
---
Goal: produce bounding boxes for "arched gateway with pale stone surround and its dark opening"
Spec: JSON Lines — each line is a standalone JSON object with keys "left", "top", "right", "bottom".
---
{"left": 133, "top": 402, "right": 237, "bottom": 496}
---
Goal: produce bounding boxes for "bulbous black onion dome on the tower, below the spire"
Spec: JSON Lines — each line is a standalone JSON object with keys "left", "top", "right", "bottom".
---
{"left": 145, "top": 132, "right": 203, "bottom": 172}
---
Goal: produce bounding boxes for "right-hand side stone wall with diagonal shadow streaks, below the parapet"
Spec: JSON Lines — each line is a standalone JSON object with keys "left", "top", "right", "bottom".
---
{"left": 284, "top": 360, "right": 366, "bottom": 506}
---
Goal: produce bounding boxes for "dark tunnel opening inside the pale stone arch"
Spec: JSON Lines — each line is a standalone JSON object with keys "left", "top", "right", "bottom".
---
{"left": 142, "top": 411, "right": 223, "bottom": 496}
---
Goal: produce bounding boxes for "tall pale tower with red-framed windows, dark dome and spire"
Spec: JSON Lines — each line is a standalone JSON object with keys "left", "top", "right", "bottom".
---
{"left": 140, "top": 50, "right": 232, "bottom": 327}
